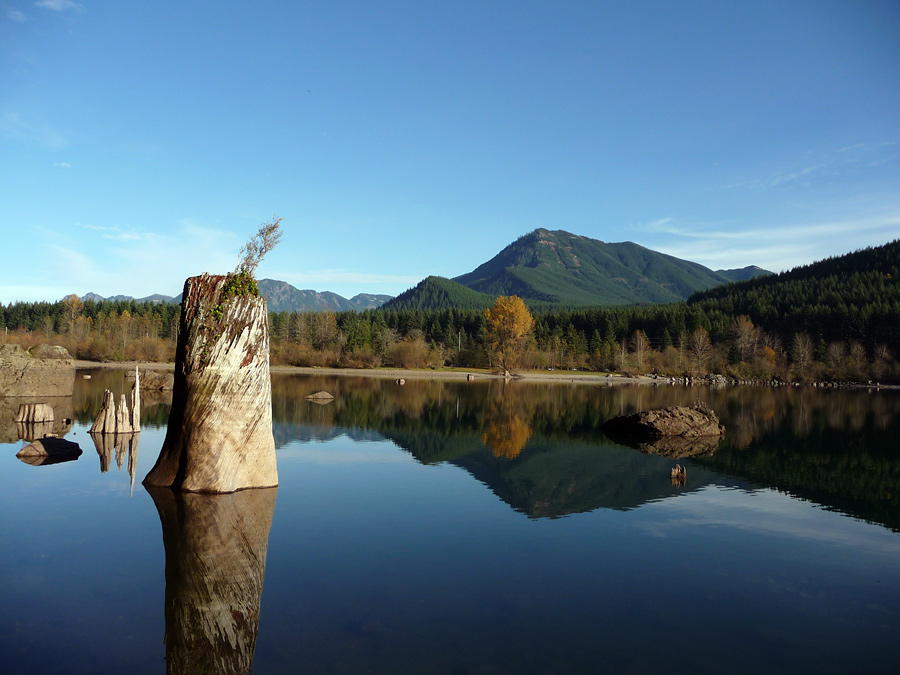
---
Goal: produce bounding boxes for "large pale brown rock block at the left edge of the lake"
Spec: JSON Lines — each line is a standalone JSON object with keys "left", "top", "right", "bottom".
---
{"left": 0, "top": 345, "right": 75, "bottom": 396}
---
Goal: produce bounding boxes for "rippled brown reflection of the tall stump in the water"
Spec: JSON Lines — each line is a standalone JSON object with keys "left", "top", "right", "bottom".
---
{"left": 147, "top": 487, "right": 278, "bottom": 675}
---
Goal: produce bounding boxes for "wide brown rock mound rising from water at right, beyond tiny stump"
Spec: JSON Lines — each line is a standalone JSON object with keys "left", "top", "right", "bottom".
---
{"left": 603, "top": 403, "right": 725, "bottom": 439}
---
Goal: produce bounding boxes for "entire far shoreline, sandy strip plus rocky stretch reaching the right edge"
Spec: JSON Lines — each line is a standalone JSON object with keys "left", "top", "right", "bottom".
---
{"left": 74, "top": 359, "right": 900, "bottom": 391}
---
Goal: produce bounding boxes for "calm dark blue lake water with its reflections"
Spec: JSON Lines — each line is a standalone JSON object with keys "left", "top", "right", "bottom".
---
{"left": 0, "top": 371, "right": 900, "bottom": 675}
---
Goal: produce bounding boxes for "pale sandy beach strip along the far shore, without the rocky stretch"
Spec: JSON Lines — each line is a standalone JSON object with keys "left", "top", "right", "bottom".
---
{"left": 75, "top": 361, "right": 661, "bottom": 385}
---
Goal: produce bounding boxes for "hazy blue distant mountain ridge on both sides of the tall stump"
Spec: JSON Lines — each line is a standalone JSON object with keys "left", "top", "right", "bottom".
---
{"left": 81, "top": 279, "right": 392, "bottom": 312}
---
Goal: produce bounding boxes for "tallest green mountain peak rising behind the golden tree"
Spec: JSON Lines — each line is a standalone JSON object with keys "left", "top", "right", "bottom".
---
{"left": 453, "top": 229, "right": 752, "bottom": 306}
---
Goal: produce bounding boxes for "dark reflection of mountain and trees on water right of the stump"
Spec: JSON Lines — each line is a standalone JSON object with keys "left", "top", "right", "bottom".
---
{"left": 273, "top": 376, "right": 900, "bottom": 531}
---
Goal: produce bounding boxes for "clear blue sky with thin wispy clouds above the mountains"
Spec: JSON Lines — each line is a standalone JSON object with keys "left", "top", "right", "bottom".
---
{"left": 0, "top": 0, "right": 900, "bottom": 302}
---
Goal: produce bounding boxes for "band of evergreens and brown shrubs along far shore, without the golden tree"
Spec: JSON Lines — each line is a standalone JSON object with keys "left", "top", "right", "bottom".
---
{"left": 0, "top": 290, "right": 900, "bottom": 380}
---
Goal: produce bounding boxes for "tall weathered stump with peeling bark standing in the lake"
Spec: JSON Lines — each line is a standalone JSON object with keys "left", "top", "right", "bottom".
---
{"left": 144, "top": 274, "right": 278, "bottom": 492}
